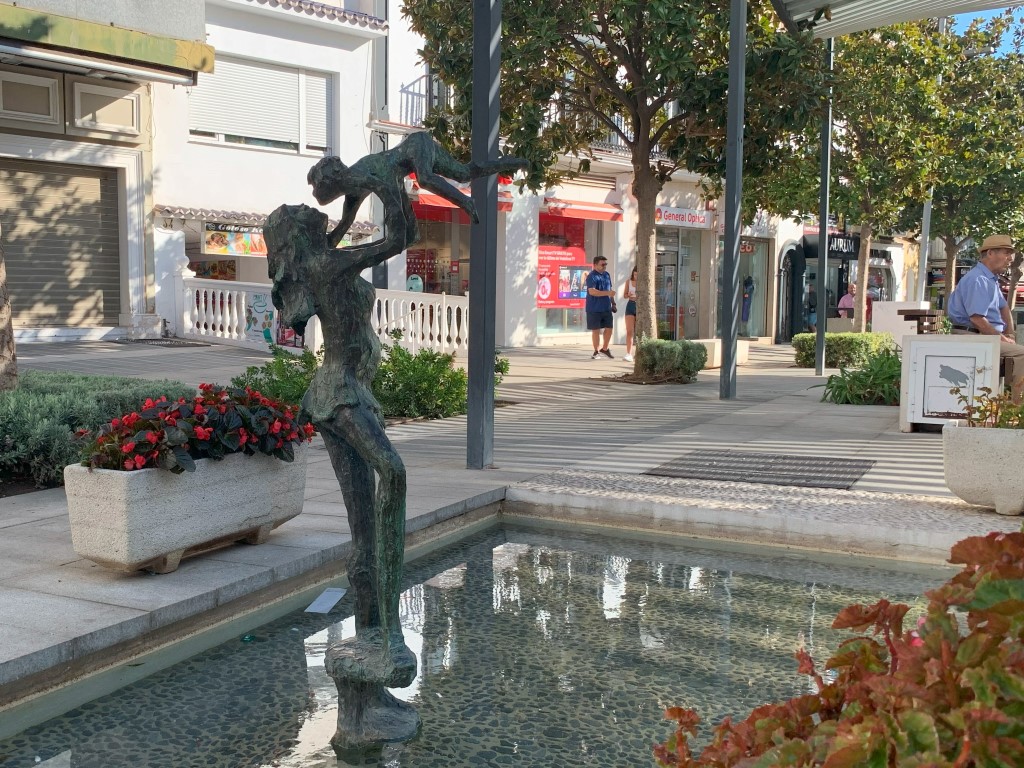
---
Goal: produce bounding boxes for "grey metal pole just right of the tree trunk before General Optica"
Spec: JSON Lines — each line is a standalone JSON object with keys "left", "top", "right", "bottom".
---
{"left": 718, "top": 0, "right": 746, "bottom": 400}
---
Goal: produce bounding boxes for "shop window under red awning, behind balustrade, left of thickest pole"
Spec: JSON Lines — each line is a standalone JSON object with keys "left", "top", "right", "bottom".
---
{"left": 406, "top": 206, "right": 469, "bottom": 296}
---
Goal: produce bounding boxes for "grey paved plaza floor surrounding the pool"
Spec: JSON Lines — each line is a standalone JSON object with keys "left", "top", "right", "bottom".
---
{"left": 0, "top": 342, "right": 1020, "bottom": 721}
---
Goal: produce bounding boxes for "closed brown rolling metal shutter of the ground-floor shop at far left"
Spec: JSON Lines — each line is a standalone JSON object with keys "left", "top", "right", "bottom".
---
{"left": 0, "top": 159, "right": 121, "bottom": 328}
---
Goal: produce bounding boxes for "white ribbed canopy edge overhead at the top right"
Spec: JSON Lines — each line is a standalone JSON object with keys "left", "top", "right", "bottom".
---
{"left": 772, "top": 0, "right": 1012, "bottom": 40}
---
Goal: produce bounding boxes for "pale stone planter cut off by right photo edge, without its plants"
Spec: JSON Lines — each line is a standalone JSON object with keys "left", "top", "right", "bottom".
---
{"left": 942, "top": 422, "right": 1024, "bottom": 515}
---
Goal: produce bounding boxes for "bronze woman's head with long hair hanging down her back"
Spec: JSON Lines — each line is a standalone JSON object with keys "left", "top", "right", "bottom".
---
{"left": 263, "top": 205, "right": 328, "bottom": 334}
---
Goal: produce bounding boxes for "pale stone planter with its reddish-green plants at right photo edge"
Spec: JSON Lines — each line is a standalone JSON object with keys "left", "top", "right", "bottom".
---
{"left": 942, "top": 387, "right": 1024, "bottom": 515}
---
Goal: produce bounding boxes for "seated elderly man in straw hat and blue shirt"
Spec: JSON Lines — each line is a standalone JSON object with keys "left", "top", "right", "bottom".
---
{"left": 946, "top": 234, "right": 1024, "bottom": 403}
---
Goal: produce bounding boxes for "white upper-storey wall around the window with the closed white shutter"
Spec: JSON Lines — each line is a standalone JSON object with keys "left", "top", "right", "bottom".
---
{"left": 154, "top": 4, "right": 371, "bottom": 224}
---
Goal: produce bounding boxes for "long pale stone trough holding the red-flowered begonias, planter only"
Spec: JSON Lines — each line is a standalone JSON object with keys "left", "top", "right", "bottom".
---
{"left": 65, "top": 443, "right": 309, "bottom": 573}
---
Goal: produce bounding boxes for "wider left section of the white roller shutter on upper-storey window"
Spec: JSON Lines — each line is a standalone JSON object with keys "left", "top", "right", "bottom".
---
{"left": 188, "top": 57, "right": 299, "bottom": 144}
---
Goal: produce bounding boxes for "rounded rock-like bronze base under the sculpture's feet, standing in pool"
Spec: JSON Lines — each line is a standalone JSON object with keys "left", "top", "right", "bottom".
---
{"left": 324, "top": 630, "right": 420, "bottom": 758}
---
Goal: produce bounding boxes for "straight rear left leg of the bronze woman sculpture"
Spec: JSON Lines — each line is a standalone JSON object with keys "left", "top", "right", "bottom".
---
{"left": 317, "top": 423, "right": 380, "bottom": 632}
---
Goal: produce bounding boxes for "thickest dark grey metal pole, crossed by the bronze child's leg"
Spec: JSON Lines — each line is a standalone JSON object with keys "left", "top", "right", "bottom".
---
{"left": 466, "top": 0, "right": 502, "bottom": 469}
